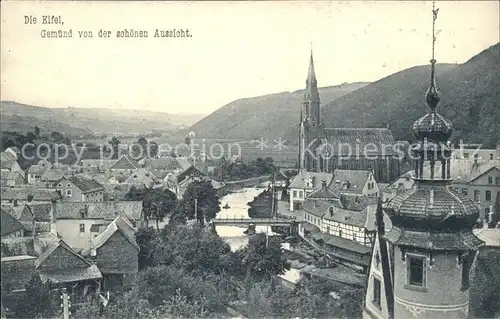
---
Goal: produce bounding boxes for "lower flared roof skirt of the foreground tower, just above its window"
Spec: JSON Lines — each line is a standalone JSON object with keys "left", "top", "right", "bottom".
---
{"left": 384, "top": 227, "right": 483, "bottom": 250}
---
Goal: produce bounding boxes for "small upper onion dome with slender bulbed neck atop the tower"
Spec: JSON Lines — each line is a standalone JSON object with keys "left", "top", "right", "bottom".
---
{"left": 412, "top": 59, "right": 453, "bottom": 142}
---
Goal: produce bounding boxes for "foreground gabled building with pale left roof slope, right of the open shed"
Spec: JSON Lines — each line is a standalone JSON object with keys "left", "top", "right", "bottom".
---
{"left": 82, "top": 214, "right": 140, "bottom": 291}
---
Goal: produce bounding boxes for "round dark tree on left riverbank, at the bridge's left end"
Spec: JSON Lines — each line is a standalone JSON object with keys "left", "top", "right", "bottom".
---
{"left": 177, "top": 180, "right": 220, "bottom": 225}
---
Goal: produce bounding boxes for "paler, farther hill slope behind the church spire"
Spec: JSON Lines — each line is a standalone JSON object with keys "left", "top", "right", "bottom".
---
{"left": 191, "top": 83, "right": 366, "bottom": 140}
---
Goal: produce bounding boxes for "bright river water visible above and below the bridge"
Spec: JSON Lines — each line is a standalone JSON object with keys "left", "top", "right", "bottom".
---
{"left": 216, "top": 188, "right": 300, "bottom": 283}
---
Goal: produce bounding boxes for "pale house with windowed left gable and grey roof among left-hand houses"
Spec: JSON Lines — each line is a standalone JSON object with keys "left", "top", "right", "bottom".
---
{"left": 56, "top": 175, "right": 104, "bottom": 202}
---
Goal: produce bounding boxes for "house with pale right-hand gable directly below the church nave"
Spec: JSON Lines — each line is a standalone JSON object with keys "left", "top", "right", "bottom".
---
{"left": 330, "top": 169, "right": 379, "bottom": 197}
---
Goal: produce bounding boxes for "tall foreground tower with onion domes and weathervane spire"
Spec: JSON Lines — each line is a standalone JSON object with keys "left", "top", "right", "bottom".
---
{"left": 363, "top": 5, "right": 483, "bottom": 318}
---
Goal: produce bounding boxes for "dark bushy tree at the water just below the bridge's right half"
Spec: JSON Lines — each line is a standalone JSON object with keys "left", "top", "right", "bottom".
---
{"left": 243, "top": 233, "right": 290, "bottom": 279}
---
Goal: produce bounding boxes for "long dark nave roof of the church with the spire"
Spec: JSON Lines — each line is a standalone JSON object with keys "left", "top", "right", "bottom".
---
{"left": 325, "top": 128, "right": 395, "bottom": 156}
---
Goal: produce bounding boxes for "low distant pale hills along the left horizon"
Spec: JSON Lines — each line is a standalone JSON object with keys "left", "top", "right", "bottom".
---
{"left": 0, "top": 101, "right": 203, "bottom": 135}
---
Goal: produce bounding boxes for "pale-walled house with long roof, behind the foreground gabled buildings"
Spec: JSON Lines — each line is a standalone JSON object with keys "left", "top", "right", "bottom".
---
{"left": 56, "top": 201, "right": 143, "bottom": 249}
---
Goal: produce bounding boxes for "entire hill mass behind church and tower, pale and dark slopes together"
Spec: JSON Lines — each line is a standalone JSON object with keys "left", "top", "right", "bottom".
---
{"left": 191, "top": 44, "right": 500, "bottom": 147}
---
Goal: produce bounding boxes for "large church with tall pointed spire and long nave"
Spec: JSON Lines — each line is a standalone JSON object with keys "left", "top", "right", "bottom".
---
{"left": 298, "top": 51, "right": 406, "bottom": 183}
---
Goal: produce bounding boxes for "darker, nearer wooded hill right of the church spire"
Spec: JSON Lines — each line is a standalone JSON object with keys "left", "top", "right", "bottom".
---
{"left": 323, "top": 44, "right": 500, "bottom": 147}
